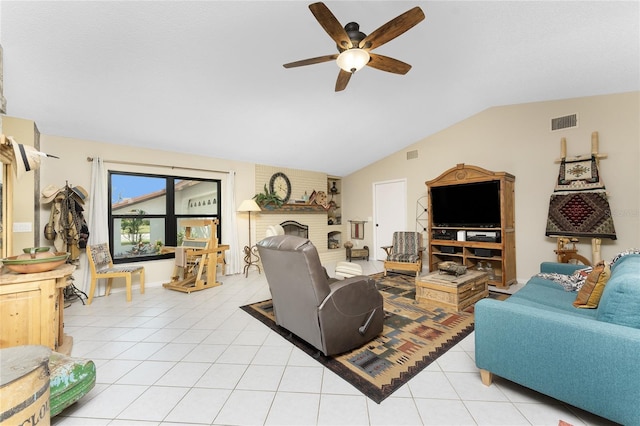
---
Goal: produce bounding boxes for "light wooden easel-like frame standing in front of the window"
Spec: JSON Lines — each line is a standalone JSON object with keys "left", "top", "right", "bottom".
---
{"left": 162, "top": 219, "right": 229, "bottom": 293}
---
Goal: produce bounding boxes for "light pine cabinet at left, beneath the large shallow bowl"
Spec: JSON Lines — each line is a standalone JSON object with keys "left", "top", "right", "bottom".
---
{"left": 0, "top": 264, "right": 75, "bottom": 354}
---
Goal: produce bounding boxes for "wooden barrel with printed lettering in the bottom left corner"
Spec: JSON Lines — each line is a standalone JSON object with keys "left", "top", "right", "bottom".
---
{"left": 0, "top": 345, "right": 51, "bottom": 426}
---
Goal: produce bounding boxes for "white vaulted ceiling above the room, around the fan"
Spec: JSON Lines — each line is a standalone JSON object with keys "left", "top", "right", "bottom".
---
{"left": 0, "top": 0, "right": 640, "bottom": 176}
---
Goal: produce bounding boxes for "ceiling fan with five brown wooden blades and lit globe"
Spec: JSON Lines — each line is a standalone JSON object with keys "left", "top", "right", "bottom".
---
{"left": 283, "top": 2, "right": 424, "bottom": 92}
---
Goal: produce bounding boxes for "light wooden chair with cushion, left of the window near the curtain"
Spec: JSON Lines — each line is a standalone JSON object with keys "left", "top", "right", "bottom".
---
{"left": 87, "top": 243, "right": 144, "bottom": 305}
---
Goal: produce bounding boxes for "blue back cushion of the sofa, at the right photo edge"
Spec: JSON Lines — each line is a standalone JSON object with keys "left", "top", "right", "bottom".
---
{"left": 596, "top": 254, "right": 640, "bottom": 328}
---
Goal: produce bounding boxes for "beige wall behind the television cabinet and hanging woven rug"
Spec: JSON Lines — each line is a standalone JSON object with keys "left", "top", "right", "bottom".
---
{"left": 343, "top": 92, "right": 640, "bottom": 282}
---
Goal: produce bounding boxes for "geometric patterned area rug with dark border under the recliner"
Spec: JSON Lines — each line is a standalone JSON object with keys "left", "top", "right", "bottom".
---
{"left": 241, "top": 274, "right": 490, "bottom": 403}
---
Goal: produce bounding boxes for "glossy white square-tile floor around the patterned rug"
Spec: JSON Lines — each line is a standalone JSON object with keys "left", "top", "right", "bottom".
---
{"left": 51, "top": 261, "right": 611, "bottom": 426}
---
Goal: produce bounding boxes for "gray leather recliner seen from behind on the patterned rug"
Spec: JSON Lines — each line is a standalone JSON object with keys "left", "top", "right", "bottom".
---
{"left": 258, "top": 235, "right": 384, "bottom": 355}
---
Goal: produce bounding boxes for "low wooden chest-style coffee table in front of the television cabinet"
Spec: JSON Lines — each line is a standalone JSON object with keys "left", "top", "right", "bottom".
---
{"left": 416, "top": 270, "right": 489, "bottom": 311}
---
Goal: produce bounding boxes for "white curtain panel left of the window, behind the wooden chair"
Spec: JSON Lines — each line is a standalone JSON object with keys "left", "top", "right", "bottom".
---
{"left": 82, "top": 157, "right": 109, "bottom": 296}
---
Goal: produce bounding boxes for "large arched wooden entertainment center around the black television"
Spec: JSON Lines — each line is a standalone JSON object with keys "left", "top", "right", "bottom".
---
{"left": 425, "top": 164, "right": 516, "bottom": 288}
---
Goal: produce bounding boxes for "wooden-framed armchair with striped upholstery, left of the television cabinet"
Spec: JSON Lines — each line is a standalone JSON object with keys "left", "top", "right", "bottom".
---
{"left": 382, "top": 231, "right": 424, "bottom": 276}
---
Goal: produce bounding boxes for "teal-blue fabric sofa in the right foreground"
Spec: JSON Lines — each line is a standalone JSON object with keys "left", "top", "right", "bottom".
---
{"left": 475, "top": 254, "right": 640, "bottom": 426}
